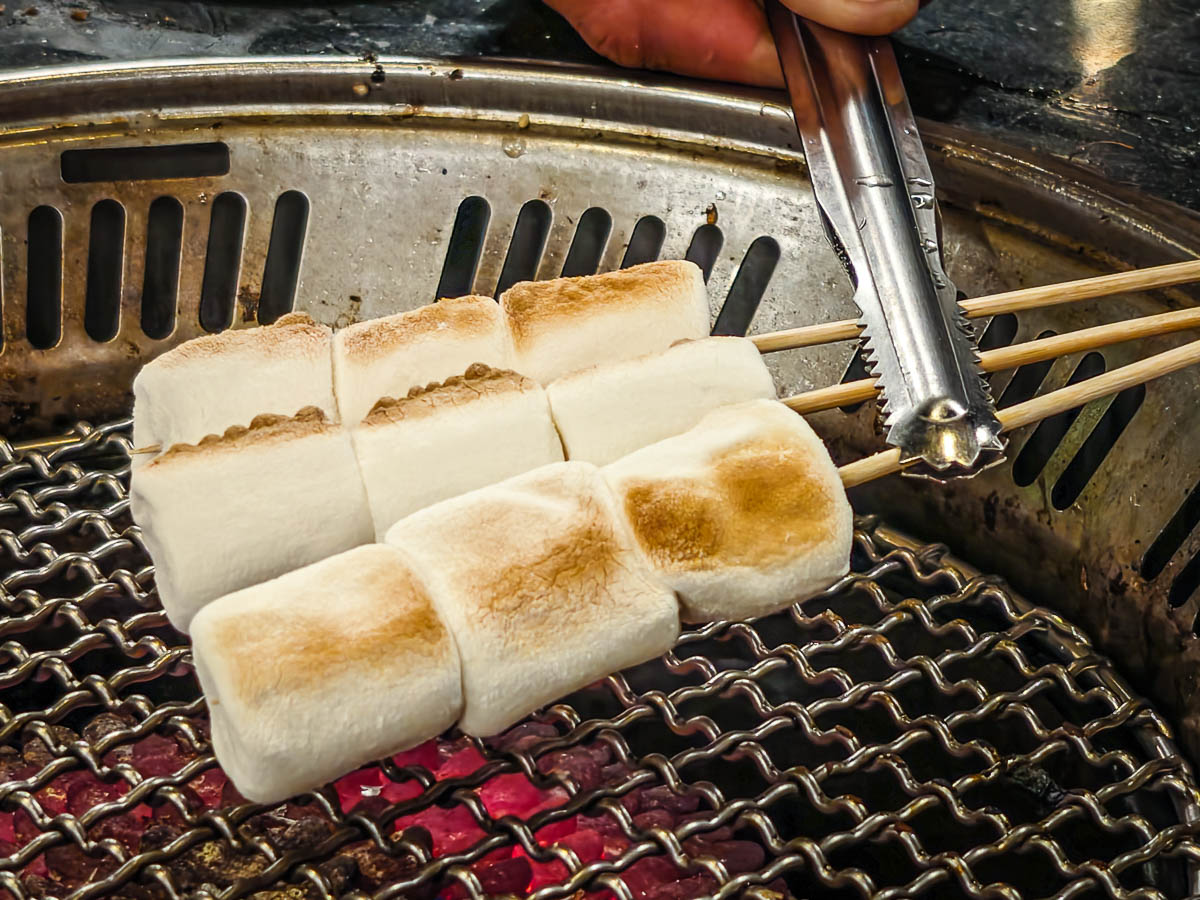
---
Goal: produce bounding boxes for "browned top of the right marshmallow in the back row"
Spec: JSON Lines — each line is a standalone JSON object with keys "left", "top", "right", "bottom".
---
{"left": 500, "top": 260, "right": 691, "bottom": 349}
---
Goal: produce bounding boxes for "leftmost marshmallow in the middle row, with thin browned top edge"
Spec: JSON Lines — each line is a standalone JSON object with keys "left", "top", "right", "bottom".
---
{"left": 130, "top": 408, "right": 373, "bottom": 631}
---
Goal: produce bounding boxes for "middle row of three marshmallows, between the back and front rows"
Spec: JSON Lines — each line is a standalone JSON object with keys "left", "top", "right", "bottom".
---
{"left": 131, "top": 336, "right": 775, "bottom": 631}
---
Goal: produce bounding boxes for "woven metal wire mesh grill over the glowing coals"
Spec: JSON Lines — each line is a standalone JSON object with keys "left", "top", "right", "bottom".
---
{"left": 0, "top": 421, "right": 1200, "bottom": 900}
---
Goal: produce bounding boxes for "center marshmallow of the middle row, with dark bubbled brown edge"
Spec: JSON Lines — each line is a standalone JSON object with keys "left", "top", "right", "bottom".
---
{"left": 352, "top": 364, "right": 563, "bottom": 540}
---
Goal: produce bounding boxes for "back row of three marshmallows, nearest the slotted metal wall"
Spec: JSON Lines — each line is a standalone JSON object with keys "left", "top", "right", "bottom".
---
{"left": 133, "top": 262, "right": 709, "bottom": 458}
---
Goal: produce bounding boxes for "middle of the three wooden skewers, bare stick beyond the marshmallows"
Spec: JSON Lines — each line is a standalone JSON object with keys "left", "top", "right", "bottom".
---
{"left": 784, "top": 308, "right": 1200, "bottom": 415}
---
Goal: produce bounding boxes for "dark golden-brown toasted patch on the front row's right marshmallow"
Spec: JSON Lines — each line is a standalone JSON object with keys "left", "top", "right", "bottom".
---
{"left": 622, "top": 434, "right": 838, "bottom": 571}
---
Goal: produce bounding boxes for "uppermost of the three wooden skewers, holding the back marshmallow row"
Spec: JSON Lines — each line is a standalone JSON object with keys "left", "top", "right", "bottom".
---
{"left": 750, "top": 259, "right": 1200, "bottom": 353}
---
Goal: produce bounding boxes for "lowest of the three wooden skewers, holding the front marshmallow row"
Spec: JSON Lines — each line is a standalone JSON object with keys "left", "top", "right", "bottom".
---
{"left": 839, "top": 341, "right": 1200, "bottom": 487}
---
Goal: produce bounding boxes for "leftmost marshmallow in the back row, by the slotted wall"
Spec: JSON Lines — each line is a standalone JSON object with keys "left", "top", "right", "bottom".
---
{"left": 133, "top": 313, "right": 337, "bottom": 450}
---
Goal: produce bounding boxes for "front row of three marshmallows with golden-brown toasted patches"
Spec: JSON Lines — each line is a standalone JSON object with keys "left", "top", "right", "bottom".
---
{"left": 192, "top": 401, "right": 851, "bottom": 803}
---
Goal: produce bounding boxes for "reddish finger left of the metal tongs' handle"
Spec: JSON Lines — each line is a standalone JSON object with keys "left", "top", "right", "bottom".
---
{"left": 546, "top": 0, "right": 784, "bottom": 88}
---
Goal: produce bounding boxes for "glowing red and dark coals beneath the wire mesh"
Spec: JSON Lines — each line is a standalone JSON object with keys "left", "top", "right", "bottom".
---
{"left": 0, "top": 713, "right": 768, "bottom": 900}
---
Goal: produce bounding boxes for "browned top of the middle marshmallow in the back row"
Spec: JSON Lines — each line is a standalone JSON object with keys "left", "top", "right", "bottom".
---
{"left": 338, "top": 296, "right": 500, "bottom": 361}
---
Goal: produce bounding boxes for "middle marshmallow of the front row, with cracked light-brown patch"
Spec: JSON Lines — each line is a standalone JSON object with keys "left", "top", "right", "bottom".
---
{"left": 388, "top": 462, "right": 679, "bottom": 736}
